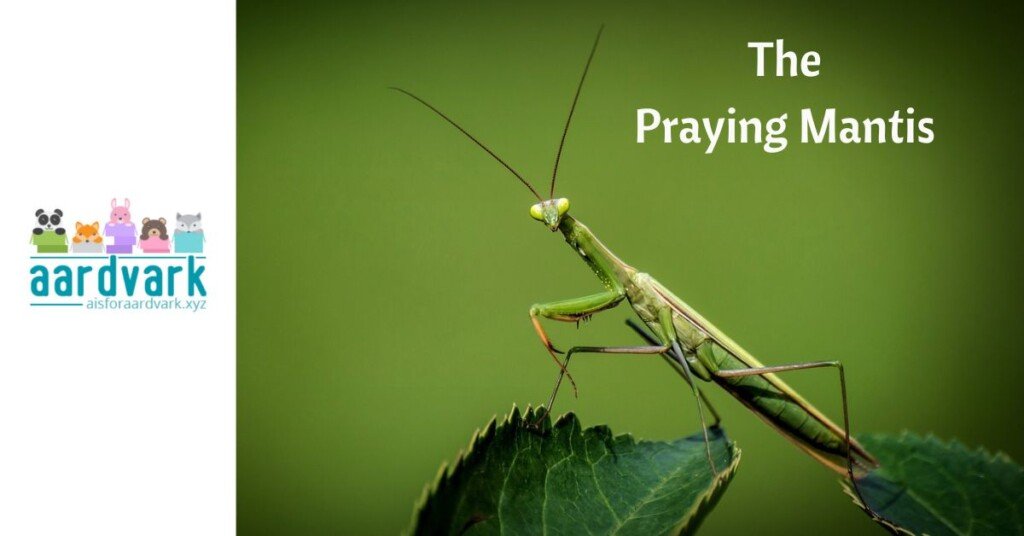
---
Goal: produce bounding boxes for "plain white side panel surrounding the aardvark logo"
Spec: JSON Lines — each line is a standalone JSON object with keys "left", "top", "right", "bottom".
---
{"left": 0, "top": 0, "right": 236, "bottom": 535}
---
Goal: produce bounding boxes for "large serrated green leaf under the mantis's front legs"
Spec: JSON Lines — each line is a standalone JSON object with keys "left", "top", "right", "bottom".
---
{"left": 411, "top": 407, "right": 739, "bottom": 535}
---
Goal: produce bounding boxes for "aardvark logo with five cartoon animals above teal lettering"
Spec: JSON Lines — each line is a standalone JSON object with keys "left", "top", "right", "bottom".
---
{"left": 29, "top": 198, "right": 207, "bottom": 313}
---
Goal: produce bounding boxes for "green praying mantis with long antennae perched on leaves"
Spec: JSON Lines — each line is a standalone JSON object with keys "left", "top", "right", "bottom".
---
{"left": 391, "top": 27, "right": 878, "bottom": 517}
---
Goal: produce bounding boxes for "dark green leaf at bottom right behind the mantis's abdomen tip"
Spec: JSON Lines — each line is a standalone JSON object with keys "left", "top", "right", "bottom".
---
{"left": 843, "top": 432, "right": 1024, "bottom": 536}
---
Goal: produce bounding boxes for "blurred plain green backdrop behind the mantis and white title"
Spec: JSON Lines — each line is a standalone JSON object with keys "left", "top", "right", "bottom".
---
{"left": 238, "top": 2, "right": 1024, "bottom": 534}
